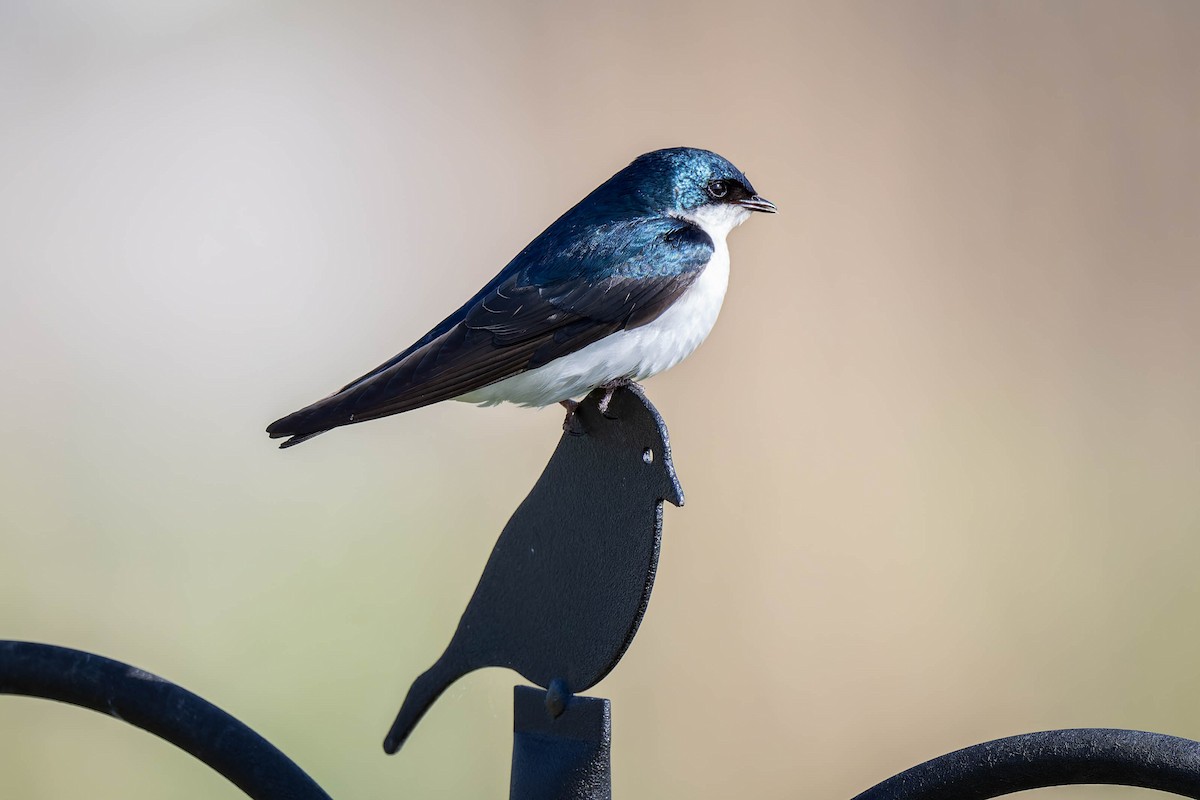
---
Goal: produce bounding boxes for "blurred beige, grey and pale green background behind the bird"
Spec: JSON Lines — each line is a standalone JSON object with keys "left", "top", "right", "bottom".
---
{"left": 0, "top": 0, "right": 1200, "bottom": 799}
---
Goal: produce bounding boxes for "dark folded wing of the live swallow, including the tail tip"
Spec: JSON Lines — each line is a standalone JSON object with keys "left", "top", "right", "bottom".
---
{"left": 266, "top": 219, "right": 713, "bottom": 447}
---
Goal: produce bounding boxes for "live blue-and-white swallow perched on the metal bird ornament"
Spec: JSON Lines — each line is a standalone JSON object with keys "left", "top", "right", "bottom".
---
{"left": 266, "top": 148, "right": 776, "bottom": 447}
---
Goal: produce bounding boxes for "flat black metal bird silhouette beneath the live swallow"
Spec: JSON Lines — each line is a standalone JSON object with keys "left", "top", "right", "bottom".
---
{"left": 384, "top": 385, "right": 683, "bottom": 753}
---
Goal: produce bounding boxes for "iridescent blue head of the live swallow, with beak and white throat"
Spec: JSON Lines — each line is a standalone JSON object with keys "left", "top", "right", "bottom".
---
{"left": 613, "top": 148, "right": 775, "bottom": 237}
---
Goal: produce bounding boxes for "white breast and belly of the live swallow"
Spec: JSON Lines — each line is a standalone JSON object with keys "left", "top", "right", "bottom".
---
{"left": 455, "top": 205, "right": 750, "bottom": 405}
